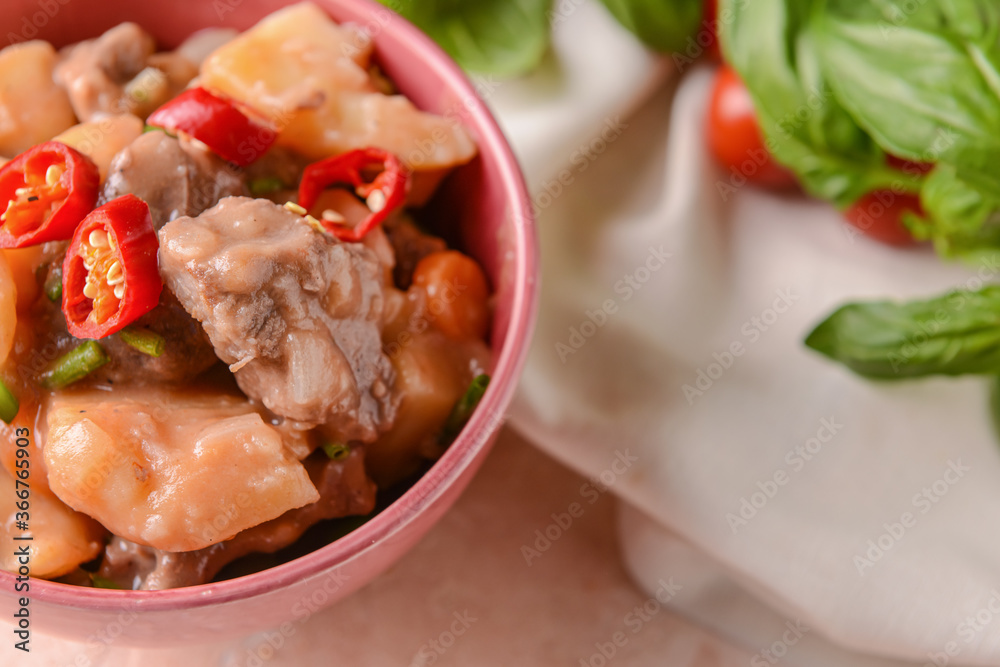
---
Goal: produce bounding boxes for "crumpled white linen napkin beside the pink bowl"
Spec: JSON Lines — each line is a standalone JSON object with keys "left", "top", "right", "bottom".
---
{"left": 498, "top": 3, "right": 1000, "bottom": 667}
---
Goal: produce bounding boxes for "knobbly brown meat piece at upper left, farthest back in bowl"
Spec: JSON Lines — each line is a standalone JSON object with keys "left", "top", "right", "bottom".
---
{"left": 54, "top": 23, "right": 198, "bottom": 121}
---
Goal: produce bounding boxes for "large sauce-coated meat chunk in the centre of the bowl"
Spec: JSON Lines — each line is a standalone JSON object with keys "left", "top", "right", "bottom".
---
{"left": 160, "top": 197, "right": 398, "bottom": 442}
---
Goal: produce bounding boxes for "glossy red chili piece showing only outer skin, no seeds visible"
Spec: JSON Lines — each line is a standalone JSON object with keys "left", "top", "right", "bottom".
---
{"left": 146, "top": 88, "right": 278, "bottom": 167}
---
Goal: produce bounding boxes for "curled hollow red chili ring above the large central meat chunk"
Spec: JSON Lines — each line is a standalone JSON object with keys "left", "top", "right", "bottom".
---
{"left": 299, "top": 148, "right": 410, "bottom": 242}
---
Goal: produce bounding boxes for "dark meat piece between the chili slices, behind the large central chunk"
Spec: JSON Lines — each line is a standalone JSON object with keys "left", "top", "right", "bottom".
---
{"left": 98, "top": 132, "right": 245, "bottom": 229}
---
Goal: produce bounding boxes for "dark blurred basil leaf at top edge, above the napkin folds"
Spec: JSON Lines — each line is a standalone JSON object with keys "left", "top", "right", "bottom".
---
{"left": 601, "top": 0, "right": 704, "bottom": 53}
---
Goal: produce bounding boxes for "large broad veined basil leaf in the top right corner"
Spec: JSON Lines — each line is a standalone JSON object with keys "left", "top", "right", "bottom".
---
{"left": 818, "top": 0, "right": 1000, "bottom": 190}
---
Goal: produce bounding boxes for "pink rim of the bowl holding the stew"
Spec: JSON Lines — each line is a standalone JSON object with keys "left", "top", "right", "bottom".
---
{"left": 0, "top": 0, "right": 539, "bottom": 612}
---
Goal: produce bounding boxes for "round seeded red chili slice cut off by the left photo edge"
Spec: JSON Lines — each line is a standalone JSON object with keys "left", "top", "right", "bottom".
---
{"left": 0, "top": 141, "right": 101, "bottom": 248}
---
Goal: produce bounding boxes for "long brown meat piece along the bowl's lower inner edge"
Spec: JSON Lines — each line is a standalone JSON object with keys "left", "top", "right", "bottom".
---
{"left": 100, "top": 448, "right": 376, "bottom": 591}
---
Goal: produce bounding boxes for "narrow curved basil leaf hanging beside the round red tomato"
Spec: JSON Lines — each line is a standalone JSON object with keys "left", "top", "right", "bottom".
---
{"left": 720, "top": 0, "right": 920, "bottom": 208}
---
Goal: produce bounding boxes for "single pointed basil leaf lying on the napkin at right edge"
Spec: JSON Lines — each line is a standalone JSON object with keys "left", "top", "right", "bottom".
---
{"left": 805, "top": 285, "right": 1000, "bottom": 380}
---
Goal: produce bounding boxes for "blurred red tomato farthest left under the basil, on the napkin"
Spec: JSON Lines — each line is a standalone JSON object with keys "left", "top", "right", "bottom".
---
{"left": 708, "top": 65, "right": 796, "bottom": 189}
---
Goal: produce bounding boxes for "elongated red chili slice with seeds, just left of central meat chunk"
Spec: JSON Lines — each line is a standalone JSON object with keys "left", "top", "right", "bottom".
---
{"left": 62, "top": 195, "right": 163, "bottom": 339}
